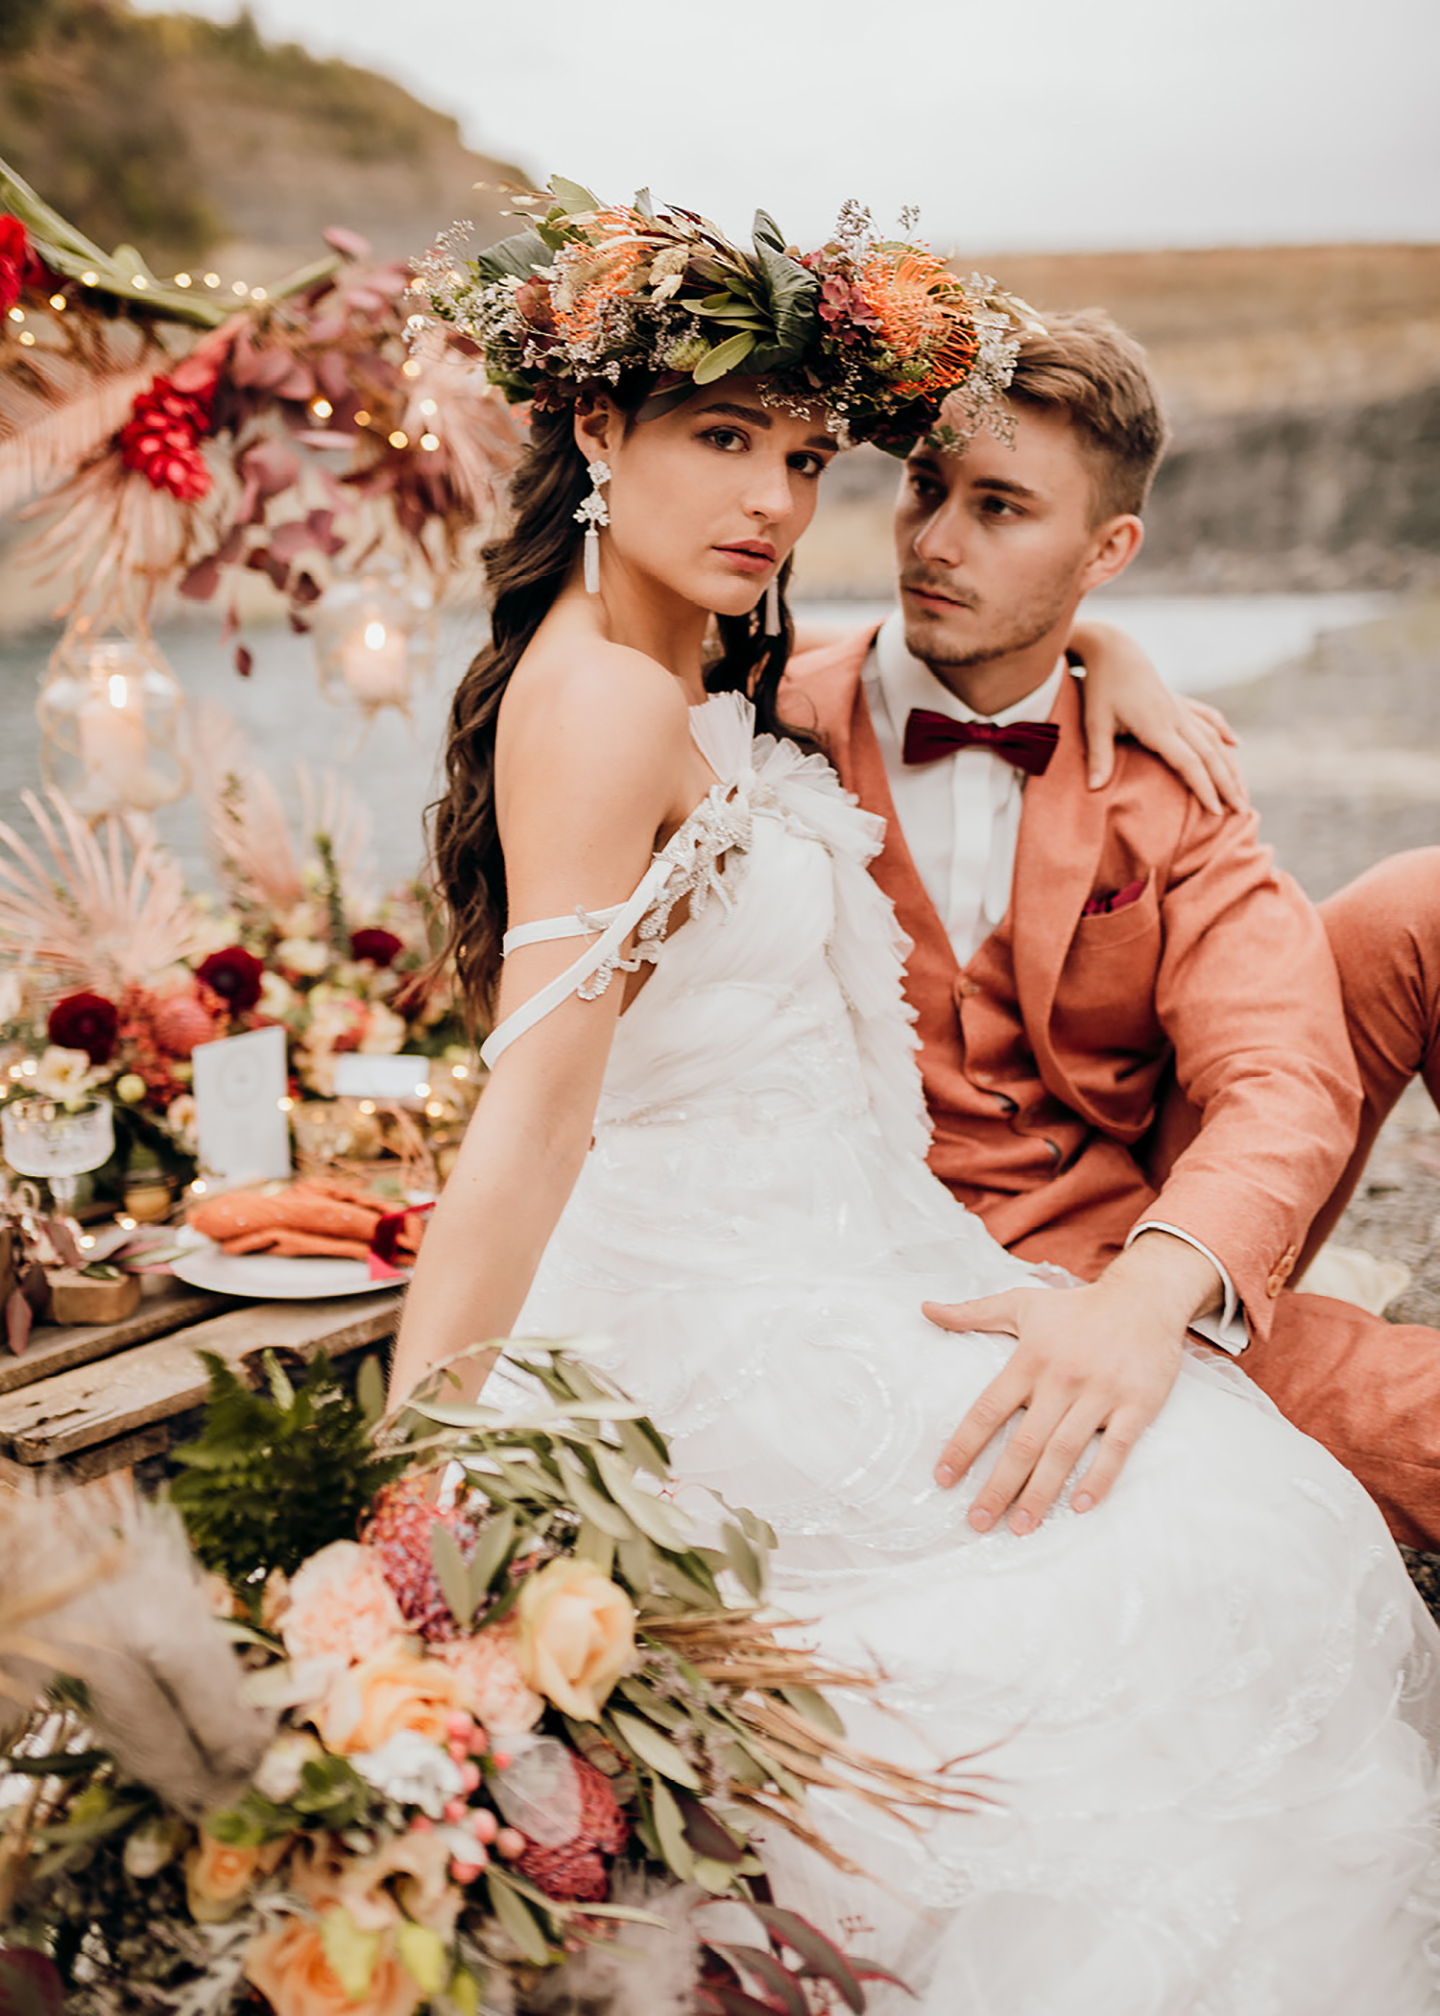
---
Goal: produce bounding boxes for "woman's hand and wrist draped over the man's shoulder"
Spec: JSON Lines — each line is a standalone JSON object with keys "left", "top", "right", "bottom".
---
{"left": 1069, "top": 623, "right": 1246, "bottom": 812}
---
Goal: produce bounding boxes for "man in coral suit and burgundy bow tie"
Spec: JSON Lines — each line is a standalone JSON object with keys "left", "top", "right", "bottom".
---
{"left": 787, "top": 312, "right": 1440, "bottom": 1548}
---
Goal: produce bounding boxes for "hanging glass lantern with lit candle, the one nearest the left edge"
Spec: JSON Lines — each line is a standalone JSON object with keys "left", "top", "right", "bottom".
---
{"left": 34, "top": 619, "right": 190, "bottom": 821}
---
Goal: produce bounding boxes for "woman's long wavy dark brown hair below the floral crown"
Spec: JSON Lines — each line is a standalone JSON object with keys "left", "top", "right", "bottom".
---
{"left": 430, "top": 387, "right": 813, "bottom": 1026}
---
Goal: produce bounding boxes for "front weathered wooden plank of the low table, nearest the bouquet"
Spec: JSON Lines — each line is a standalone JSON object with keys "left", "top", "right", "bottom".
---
{"left": 0, "top": 1292, "right": 401, "bottom": 1464}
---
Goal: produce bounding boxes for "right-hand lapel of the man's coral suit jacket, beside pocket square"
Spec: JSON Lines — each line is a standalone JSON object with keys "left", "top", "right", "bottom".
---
{"left": 1010, "top": 677, "right": 1109, "bottom": 1070}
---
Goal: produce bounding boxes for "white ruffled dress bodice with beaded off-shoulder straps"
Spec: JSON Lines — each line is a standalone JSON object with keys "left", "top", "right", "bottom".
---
{"left": 482, "top": 694, "right": 930, "bottom": 1163}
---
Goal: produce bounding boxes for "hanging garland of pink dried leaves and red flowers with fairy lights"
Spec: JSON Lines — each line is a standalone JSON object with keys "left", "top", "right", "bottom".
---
{"left": 0, "top": 161, "right": 520, "bottom": 671}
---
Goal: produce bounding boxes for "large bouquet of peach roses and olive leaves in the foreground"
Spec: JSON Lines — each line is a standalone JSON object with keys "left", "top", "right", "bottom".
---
{"left": 0, "top": 1345, "right": 972, "bottom": 2016}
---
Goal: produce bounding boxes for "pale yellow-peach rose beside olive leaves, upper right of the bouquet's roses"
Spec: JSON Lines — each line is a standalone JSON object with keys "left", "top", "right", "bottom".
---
{"left": 514, "top": 1556, "right": 635, "bottom": 1722}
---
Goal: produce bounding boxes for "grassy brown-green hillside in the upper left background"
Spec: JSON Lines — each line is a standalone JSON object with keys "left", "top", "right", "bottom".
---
{"left": 0, "top": 0, "right": 516, "bottom": 282}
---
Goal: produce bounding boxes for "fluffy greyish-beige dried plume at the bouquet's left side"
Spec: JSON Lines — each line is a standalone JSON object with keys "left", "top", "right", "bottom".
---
{"left": 0, "top": 1494, "right": 272, "bottom": 1818}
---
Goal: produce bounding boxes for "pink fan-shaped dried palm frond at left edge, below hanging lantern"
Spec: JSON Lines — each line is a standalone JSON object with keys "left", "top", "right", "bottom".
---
{"left": 0, "top": 790, "right": 202, "bottom": 992}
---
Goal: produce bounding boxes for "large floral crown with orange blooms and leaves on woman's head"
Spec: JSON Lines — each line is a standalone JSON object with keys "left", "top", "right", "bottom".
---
{"left": 411, "top": 175, "right": 1037, "bottom": 456}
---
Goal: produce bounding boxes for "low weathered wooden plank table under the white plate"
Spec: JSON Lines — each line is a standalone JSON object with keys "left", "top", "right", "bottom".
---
{"left": 0, "top": 1280, "right": 401, "bottom": 1492}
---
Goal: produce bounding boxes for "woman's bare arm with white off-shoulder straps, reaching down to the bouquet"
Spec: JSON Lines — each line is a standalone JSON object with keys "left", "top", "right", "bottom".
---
{"left": 389, "top": 653, "right": 690, "bottom": 1405}
